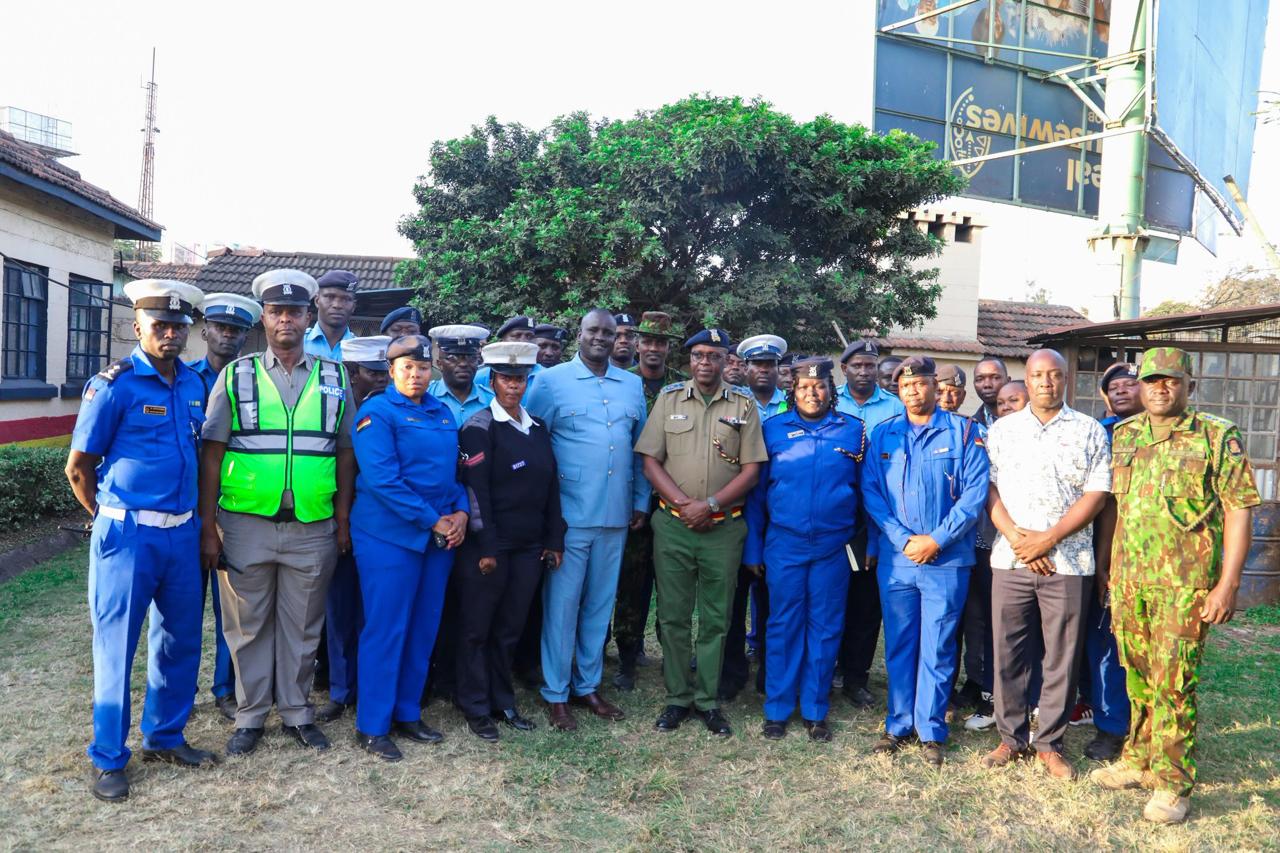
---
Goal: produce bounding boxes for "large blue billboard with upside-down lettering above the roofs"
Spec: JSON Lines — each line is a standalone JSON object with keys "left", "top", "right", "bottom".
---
{"left": 874, "top": 0, "right": 1196, "bottom": 233}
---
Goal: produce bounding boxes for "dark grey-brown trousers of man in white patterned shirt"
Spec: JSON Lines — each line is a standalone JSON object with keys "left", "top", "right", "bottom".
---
{"left": 991, "top": 569, "right": 1093, "bottom": 752}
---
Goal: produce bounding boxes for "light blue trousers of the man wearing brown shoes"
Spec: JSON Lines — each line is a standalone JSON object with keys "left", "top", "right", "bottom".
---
{"left": 541, "top": 526, "right": 627, "bottom": 702}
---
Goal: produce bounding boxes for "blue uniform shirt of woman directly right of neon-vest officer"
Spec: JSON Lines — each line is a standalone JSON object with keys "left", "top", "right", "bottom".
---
{"left": 351, "top": 386, "right": 470, "bottom": 551}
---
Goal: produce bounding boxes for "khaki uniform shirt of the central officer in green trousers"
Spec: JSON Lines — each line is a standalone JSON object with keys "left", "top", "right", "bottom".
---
{"left": 635, "top": 379, "right": 769, "bottom": 501}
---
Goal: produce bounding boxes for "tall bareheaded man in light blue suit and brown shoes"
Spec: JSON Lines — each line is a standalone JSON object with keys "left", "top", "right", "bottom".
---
{"left": 527, "top": 309, "right": 649, "bottom": 731}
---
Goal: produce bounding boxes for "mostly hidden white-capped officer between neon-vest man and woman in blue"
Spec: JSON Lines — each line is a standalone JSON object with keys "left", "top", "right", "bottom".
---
{"left": 316, "top": 334, "right": 392, "bottom": 722}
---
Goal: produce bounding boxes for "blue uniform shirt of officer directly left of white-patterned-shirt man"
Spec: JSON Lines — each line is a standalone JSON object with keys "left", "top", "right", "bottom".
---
{"left": 863, "top": 409, "right": 991, "bottom": 567}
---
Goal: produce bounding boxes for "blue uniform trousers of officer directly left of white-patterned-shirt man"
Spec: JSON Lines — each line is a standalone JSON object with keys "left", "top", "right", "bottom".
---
{"left": 878, "top": 564, "right": 970, "bottom": 743}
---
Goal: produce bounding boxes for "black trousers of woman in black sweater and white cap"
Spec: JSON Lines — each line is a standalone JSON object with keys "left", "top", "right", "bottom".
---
{"left": 451, "top": 544, "right": 543, "bottom": 717}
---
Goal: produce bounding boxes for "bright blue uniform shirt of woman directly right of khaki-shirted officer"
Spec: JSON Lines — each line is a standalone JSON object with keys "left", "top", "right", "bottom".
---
{"left": 742, "top": 410, "right": 867, "bottom": 565}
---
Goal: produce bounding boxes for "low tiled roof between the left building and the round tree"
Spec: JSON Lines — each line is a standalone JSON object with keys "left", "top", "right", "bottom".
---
{"left": 195, "top": 248, "right": 404, "bottom": 296}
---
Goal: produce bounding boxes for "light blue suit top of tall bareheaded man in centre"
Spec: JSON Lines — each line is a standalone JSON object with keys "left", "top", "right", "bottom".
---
{"left": 526, "top": 356, "right": 650, "bottom": 528}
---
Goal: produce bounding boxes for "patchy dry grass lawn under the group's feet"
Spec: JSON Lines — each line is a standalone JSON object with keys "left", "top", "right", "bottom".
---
{"left": 0, "top": 540, "right": 1280, "bottom": 850}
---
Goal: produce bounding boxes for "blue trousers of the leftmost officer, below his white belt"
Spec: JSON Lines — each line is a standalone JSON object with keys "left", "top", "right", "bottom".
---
{"left": 87, "top": 512, "right": 202, "bottom": 770}
